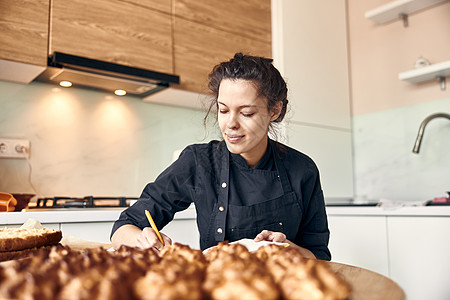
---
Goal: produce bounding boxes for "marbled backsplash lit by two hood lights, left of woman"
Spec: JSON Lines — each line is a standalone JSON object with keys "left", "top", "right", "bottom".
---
{"left": 0, "top": 81, "right": 217, "bottom": 196}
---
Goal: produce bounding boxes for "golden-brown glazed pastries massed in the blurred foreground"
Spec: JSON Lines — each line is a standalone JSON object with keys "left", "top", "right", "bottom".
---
{"left": 0, "top": 243, "right": 350, "bottom": 300}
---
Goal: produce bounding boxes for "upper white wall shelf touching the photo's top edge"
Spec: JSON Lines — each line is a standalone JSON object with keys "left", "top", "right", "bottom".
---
{"left": 364, "top": 0, "right": 448, "bottom": 26}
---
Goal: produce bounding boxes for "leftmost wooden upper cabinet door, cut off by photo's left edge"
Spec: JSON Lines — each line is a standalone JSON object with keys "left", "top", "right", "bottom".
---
{"left": 0, "top": 0, "right": 49, "bottom": 66}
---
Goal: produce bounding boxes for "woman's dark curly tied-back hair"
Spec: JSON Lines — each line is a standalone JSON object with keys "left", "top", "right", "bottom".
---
{"left": 204, "top": 52, "right": 288, "bottom": 125}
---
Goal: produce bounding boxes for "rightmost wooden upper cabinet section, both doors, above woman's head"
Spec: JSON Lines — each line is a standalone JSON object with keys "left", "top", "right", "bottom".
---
{"left": 173, "top": 0, "right": 272, "bottom": 94}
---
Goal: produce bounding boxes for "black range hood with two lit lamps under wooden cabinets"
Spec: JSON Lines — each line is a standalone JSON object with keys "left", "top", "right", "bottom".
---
{"left": 36, "top": 52, "right": 180, "bottom": 97}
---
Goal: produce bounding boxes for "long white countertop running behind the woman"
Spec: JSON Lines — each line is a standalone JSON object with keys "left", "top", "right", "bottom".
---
{"left": 0, "top": 206, "right": 450, "bottom": 226}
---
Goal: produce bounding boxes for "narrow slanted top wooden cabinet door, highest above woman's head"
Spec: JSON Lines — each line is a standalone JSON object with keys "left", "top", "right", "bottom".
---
{"left": 173, "top": 0, "right": 272, "bottom": 43}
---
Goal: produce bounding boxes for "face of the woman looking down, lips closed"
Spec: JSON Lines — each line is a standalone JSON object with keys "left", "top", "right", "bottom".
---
{"left": 217, "top": 79, "right": 281, "bottom": 167}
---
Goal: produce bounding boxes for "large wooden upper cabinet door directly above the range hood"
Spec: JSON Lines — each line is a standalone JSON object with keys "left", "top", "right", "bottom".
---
{"left": 49, "top": 0, "right": 173, "bottom": 73}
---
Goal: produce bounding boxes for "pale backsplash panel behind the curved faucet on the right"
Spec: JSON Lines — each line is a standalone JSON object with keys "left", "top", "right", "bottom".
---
{"left": 353, "top": 98, "right": 450, "bottom": 201}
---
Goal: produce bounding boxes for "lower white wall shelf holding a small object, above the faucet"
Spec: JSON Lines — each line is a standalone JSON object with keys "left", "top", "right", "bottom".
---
{"left": 398, "top": 60, "right": 450, "bottom": 90}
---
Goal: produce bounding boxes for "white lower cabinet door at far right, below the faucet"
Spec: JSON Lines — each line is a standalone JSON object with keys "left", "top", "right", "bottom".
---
{"left": 388, "top": 217, "right": 450, "bottom": 300}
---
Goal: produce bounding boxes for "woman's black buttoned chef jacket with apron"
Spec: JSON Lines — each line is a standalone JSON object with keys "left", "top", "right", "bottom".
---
{"left": 112, "top": 139, "right": 331, "bottom": 260}
